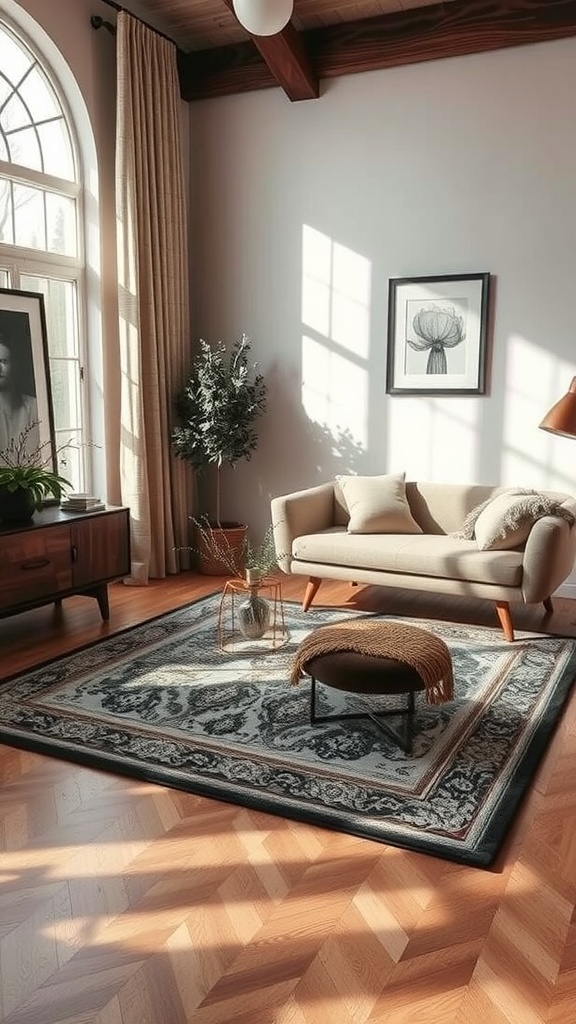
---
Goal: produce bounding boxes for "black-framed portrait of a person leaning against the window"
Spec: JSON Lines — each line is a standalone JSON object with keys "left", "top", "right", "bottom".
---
{"left": 0, "top": 288, "right": 56, "bottom": 470}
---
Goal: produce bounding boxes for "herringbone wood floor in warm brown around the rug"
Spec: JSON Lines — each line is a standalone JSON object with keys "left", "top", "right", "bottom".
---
{"left": 0, "top": 574, "right": 576, "bottom": 1024}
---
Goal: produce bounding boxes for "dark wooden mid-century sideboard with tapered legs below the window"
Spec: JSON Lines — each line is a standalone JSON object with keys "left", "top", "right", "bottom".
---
{"left": 0, "top": 507, "right": 130, "bottom": 620}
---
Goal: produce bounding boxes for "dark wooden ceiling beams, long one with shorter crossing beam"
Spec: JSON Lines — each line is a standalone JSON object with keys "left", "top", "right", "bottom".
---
{"left": 178, "top": 0, "right": 576, "bottom": 100}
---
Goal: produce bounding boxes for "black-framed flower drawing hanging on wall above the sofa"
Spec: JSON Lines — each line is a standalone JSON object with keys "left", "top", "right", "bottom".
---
{"left": 386, "top": 273, "right": 490, "bottom": 394}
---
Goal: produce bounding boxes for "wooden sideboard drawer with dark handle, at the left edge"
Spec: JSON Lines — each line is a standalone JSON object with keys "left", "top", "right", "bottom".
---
{"left": 0, "top": 526, "right": 72, "bottom": 611}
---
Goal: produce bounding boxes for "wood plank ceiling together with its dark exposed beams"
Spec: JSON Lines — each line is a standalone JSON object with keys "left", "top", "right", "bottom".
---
{"left": 119, "top": 0, "right": 576, "bottom": 100}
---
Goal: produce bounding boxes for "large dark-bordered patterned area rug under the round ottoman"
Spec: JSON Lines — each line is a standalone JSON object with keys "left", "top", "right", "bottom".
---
{"left": 0, "top": 596, "right": 576, "bottom": 866}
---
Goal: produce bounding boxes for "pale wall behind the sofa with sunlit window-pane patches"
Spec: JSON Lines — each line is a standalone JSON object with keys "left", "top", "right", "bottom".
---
{"left": 191, "top": 40, "right": 576, "bottom": 585}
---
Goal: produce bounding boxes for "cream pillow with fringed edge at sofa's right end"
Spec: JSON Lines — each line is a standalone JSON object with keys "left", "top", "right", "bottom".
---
{"left": 475, "top": 492, "right": 574, "bottom": 551}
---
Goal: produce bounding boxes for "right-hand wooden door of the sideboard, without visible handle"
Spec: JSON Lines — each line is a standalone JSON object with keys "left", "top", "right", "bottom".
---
{"left": 70, "top": 509, "right": 130, "bottom": 587}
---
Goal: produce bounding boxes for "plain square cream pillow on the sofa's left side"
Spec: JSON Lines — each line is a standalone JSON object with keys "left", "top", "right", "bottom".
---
{"left": 336, "top": 473, "right": 422, "bottom": 534}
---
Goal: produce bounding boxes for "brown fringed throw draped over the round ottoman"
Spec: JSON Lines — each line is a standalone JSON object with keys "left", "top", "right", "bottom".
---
{"left": 290, "top": 618, "right": 454, "bottom": 705}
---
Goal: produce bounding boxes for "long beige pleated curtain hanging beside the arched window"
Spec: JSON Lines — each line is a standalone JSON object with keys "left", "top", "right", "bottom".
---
{"left": 116, "top": 11, "right": 192, "bottom": 585}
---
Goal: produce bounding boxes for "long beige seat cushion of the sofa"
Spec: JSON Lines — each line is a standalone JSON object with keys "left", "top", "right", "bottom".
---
{"left": 292, "top": 526, "right": 523, "bottom": 587}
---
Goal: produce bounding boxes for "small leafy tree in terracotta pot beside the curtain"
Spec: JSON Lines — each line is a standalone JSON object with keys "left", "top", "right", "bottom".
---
{"left": 172, "top": 334, "right": 266, "bottom": 575}
